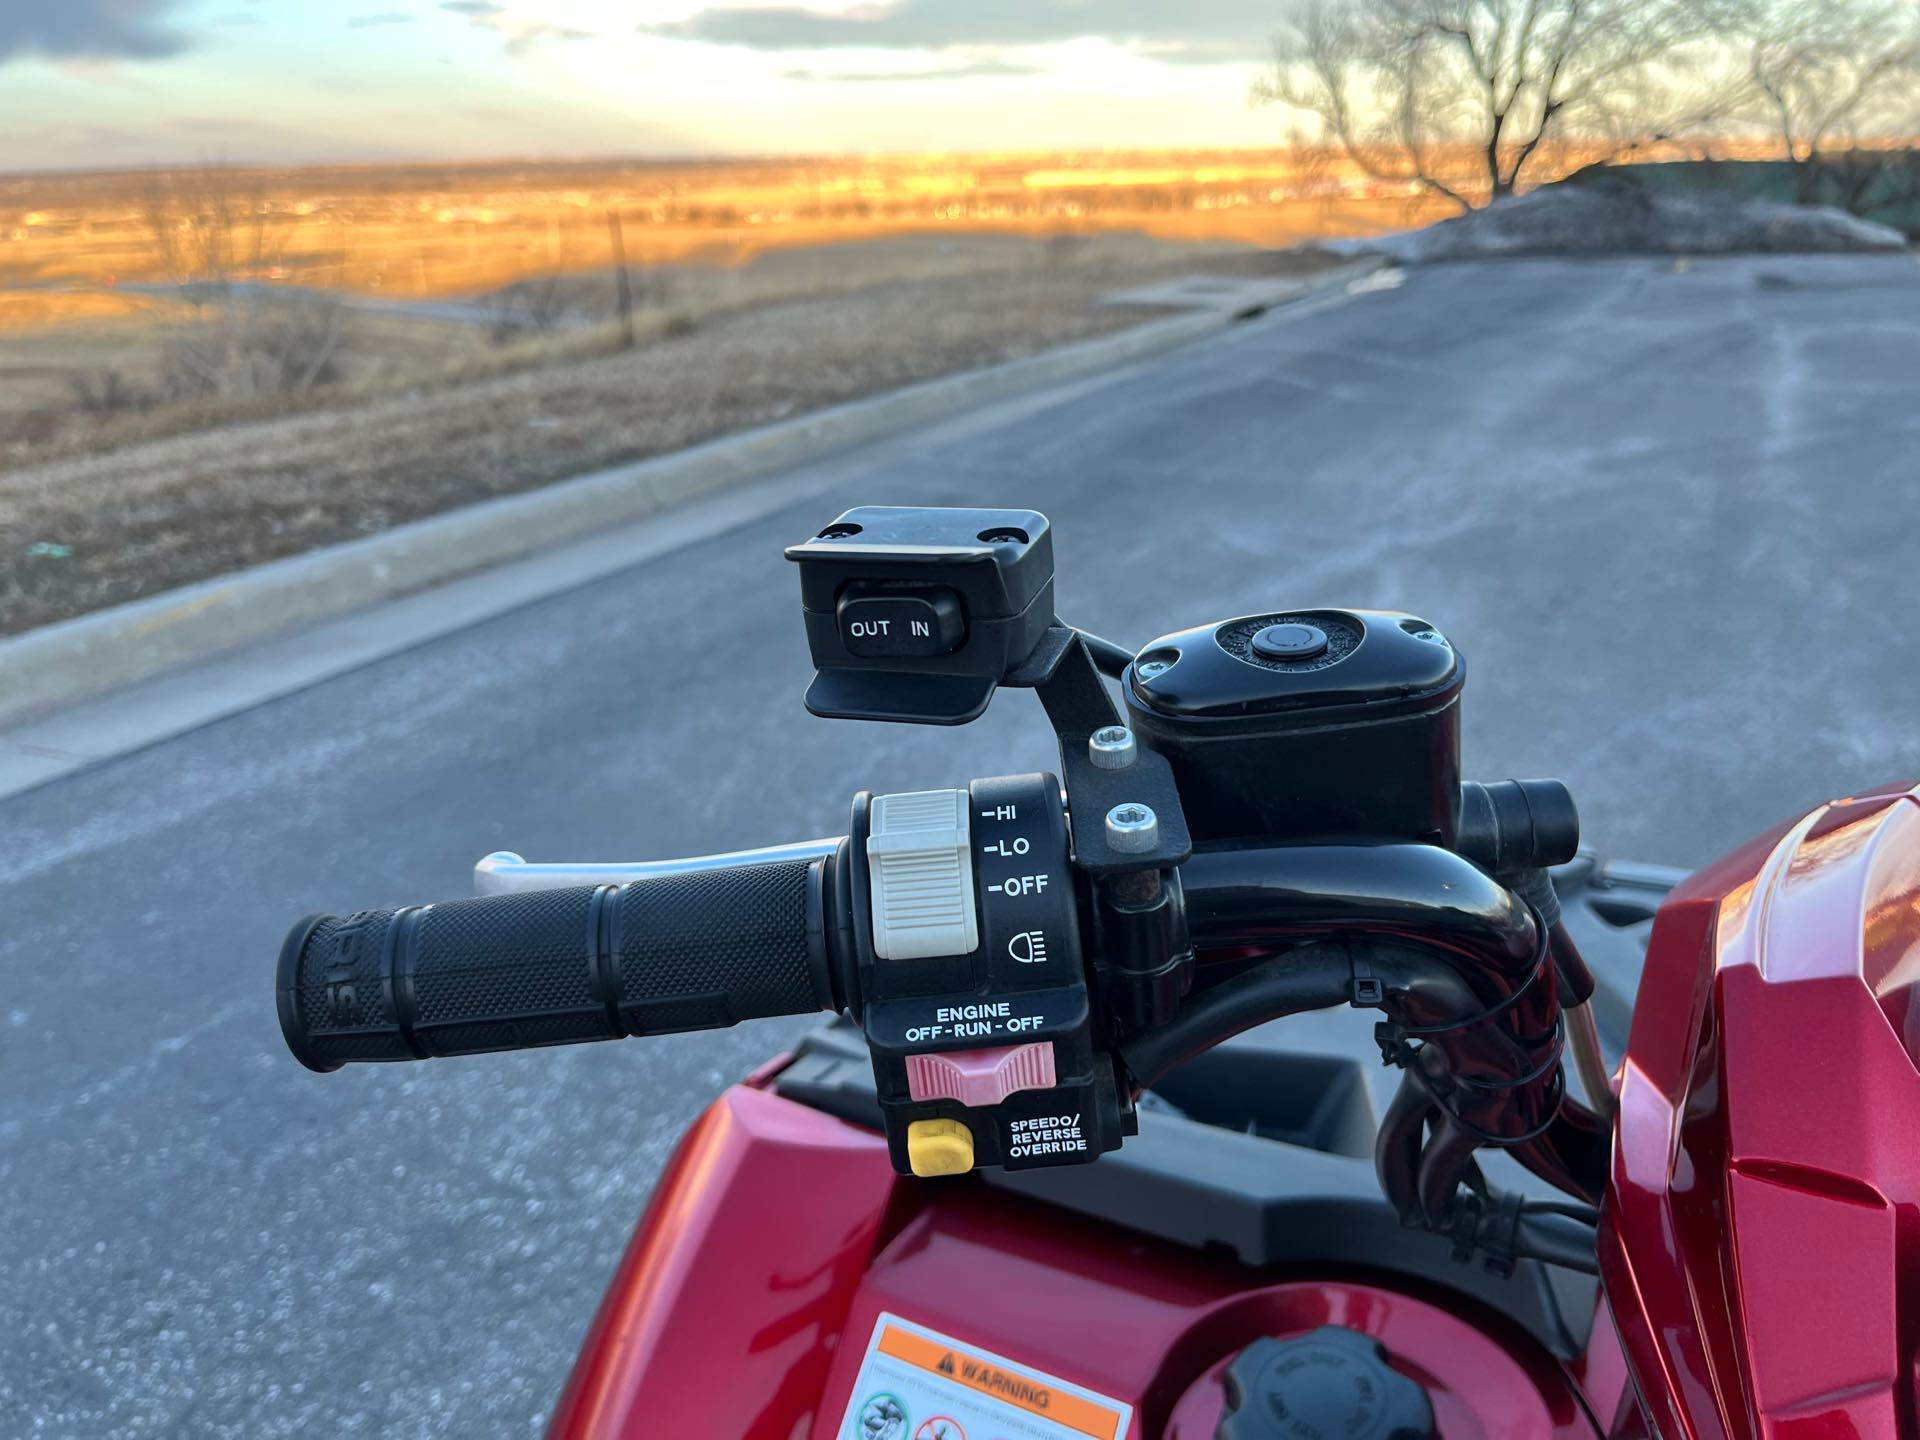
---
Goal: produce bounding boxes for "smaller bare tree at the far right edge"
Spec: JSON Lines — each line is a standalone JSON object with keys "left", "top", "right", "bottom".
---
{"left": 1749, "top": 0, "right": 1920, "bottom": 213}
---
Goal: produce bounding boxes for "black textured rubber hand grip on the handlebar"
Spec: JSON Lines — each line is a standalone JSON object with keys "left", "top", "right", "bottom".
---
{"left": 278, "top": 860, "right": 835, "bottom": 1069}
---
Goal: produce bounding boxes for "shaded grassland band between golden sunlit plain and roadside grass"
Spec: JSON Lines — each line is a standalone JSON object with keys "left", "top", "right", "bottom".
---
{"left": 0, "top": 232, "right": 1290, "bottom": 458}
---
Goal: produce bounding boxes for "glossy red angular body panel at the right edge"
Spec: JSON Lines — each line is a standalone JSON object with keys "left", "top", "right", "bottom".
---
{"left": 1601, "top": 791, "right": 1920, "bottom": 1440}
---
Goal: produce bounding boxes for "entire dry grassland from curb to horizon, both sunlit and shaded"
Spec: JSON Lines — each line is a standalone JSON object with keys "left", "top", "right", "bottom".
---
{"left": 18, "top": 152, "right": 1681, "bottom": 634}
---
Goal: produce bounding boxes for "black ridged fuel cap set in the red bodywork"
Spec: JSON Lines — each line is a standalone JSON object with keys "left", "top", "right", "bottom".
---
{"left": 1213, "top": 1325, "right": 1434, "bottom": 1440}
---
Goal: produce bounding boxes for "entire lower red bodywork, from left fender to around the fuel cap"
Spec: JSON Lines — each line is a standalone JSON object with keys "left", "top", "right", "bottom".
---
{"left": 549, "top": 1087, "right": 1620, "bottom": 1440}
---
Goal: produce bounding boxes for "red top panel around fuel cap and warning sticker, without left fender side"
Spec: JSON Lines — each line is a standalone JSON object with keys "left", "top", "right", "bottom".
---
{"left": 808, "top": 1185, "right": 1594, "bottom": 1440}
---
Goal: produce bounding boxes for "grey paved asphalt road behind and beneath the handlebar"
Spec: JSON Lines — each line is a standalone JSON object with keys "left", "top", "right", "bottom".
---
{"left": 0, "top": 259, "right": 1920, "bottom": 1438}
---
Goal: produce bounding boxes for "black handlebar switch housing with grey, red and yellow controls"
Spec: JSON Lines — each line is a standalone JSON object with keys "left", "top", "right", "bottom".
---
{"left": 852, "top": 776, "right": 1133, "bottom": 1175}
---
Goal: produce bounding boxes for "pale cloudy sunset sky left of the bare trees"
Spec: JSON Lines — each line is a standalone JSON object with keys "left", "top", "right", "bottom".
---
{"left": 0, "top": 0, "right": 1286, "bottom": 171}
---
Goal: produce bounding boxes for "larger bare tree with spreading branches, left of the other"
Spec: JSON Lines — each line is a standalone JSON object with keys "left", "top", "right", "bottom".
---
{"left": 1254, "top": 0, "right": 1738, "bottom": 209}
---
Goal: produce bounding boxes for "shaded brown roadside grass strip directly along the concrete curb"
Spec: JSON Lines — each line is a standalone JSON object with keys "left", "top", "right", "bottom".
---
{"left": 0, "top": 221, "right": 1332, "bottom": 634}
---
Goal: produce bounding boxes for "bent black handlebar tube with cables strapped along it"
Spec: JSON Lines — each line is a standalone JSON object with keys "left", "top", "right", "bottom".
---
{"left": 1121, "top": 845, "right": 1607, "bottom": 1265}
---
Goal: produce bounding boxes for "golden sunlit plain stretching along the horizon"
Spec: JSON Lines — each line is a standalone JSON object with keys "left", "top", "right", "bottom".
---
{"left": 0, "top": 150, "right": 1405, "bottom": 296}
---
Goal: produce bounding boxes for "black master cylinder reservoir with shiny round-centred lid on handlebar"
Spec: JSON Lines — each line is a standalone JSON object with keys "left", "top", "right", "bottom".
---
{"left": 1123, "top": 611, "right": 1467, "bottom": 847}
